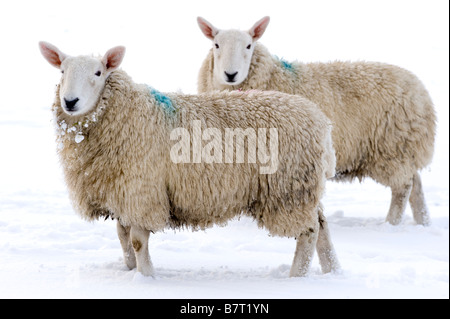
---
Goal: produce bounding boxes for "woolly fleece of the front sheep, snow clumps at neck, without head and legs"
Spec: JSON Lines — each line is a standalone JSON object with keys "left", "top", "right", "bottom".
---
{"left": 53, "top": 70, "right": 335, "bottom": 237}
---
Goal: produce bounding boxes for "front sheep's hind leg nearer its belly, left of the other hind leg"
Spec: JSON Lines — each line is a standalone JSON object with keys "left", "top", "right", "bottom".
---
{"left": 289, "top": 222, "right": 319, "bottom": 277}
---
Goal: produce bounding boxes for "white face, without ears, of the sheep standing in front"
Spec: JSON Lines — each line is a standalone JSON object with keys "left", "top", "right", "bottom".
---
{"left": 59, "top": 56, "right": 107, "bottom": 116}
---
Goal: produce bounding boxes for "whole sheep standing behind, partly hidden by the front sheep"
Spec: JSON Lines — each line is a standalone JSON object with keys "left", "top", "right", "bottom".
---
{"left": 197, "top": 17, "right": 436, "bottom": 225}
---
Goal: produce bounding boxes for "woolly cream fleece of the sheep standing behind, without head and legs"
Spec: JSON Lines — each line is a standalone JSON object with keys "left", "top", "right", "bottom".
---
{"left": 198, "top": 42, "right": 436, "bottom": 188}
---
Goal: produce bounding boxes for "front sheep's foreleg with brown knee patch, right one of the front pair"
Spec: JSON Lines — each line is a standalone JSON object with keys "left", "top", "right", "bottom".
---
{"left": 130, "top": 226, "right": 153, "bottom": 276}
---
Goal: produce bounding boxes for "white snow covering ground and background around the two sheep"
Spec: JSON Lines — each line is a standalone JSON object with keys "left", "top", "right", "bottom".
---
{"left": 0, "top": 0, "right": 449, "bottom": 299}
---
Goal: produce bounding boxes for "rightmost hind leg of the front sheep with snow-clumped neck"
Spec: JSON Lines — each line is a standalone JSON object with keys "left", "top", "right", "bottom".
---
{"left": 316, "top": 204, "right": 340, "bottom": 274}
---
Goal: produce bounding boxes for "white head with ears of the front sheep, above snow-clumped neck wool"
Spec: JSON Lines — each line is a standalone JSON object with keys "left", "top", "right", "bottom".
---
{"left": 39, "top": 42, "right": 125, "bottom": 116}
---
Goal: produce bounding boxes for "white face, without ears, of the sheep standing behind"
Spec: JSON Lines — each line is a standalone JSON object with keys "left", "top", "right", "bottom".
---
{"left": 213, "top": 30, "right": 254, "bottom": 85}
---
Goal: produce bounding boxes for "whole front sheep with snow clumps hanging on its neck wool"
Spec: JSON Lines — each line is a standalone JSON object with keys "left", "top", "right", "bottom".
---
{"left": 39, "top": 42, "right": 340, "bottom": 276}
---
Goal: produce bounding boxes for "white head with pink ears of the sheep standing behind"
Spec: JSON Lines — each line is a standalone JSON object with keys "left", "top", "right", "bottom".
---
{"left": 197, "top": 17, "right": 270, "bottom": 86}
